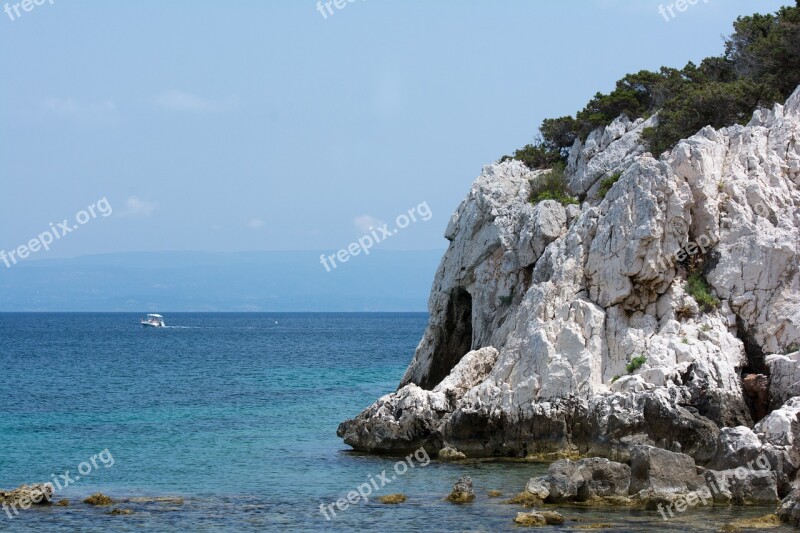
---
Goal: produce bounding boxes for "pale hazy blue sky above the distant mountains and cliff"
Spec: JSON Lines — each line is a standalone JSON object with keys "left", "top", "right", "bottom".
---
{"left": 0, "top": 0, "right": 787, "bottom": 258}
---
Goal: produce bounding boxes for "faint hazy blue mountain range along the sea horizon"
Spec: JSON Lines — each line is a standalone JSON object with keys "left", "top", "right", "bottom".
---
{"left": 0, "top": 250, "right": 443, "bottom": 312}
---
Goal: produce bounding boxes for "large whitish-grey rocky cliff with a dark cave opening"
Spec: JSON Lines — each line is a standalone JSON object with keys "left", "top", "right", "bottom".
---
{"left": 339, "top": 89, "right": 800, "bottom": 512}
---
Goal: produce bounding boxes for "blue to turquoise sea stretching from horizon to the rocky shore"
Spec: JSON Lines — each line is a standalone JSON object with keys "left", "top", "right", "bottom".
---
{"left": 0, "top": 314, "right": 788, "bottom": 531}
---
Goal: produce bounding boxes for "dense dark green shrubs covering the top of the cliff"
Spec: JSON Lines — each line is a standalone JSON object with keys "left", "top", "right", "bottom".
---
{"left": 501, "top": 0, "right": 800, "bottom": 169}
